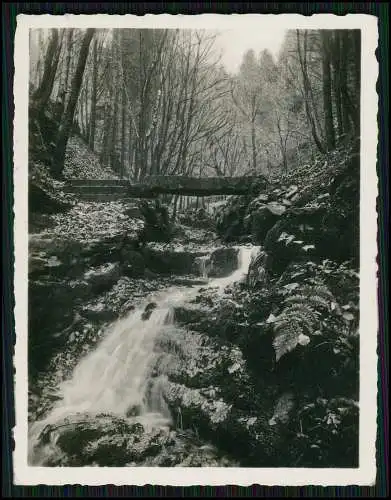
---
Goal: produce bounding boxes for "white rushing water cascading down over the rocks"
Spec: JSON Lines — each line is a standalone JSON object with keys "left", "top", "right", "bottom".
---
{"left": 30, "top": 246, "right": 258, "bottom": 462}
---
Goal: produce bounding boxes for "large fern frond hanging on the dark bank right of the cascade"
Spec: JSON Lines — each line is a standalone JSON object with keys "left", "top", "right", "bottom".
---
{"left": 273, "top": 285, "right": 335, "bottom": 361}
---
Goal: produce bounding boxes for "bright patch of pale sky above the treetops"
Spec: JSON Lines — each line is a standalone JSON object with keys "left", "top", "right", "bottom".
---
{"left": 215, "top": 27, "right": 286, "bottom": 73}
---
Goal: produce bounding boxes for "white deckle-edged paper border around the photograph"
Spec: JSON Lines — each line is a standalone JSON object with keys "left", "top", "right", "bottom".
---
{"left": 13, "top": 14, "right": 378, "bottom": 486}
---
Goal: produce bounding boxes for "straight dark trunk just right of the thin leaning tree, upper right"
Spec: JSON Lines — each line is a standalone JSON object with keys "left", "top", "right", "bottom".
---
{"left": 321, "top": 30, "right": 335, "bottom": 151}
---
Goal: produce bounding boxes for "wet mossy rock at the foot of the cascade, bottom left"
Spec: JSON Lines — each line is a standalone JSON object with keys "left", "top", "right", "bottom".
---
{"left": 34, "top": 415, "right": 236, "bottom": 467}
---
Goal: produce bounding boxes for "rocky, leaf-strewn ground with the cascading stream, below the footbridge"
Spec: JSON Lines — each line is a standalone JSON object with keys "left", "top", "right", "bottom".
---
{"left": 28, "top": 141, "right": 359, "bottom": 467}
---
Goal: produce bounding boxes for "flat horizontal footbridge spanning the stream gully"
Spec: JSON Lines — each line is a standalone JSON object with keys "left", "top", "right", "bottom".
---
{"left": 64, "top": 176, "right": 267, "bottom": 201}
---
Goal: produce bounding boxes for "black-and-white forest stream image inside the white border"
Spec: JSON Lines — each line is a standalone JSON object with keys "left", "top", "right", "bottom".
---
{"left": 13, "top": 14, "right": 376, "bottom": 484}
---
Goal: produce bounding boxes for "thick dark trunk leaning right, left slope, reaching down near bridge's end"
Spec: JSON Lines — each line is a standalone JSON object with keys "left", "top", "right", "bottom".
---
{"left": 53, "top": 28, "right": 95, "bottom": 176}
